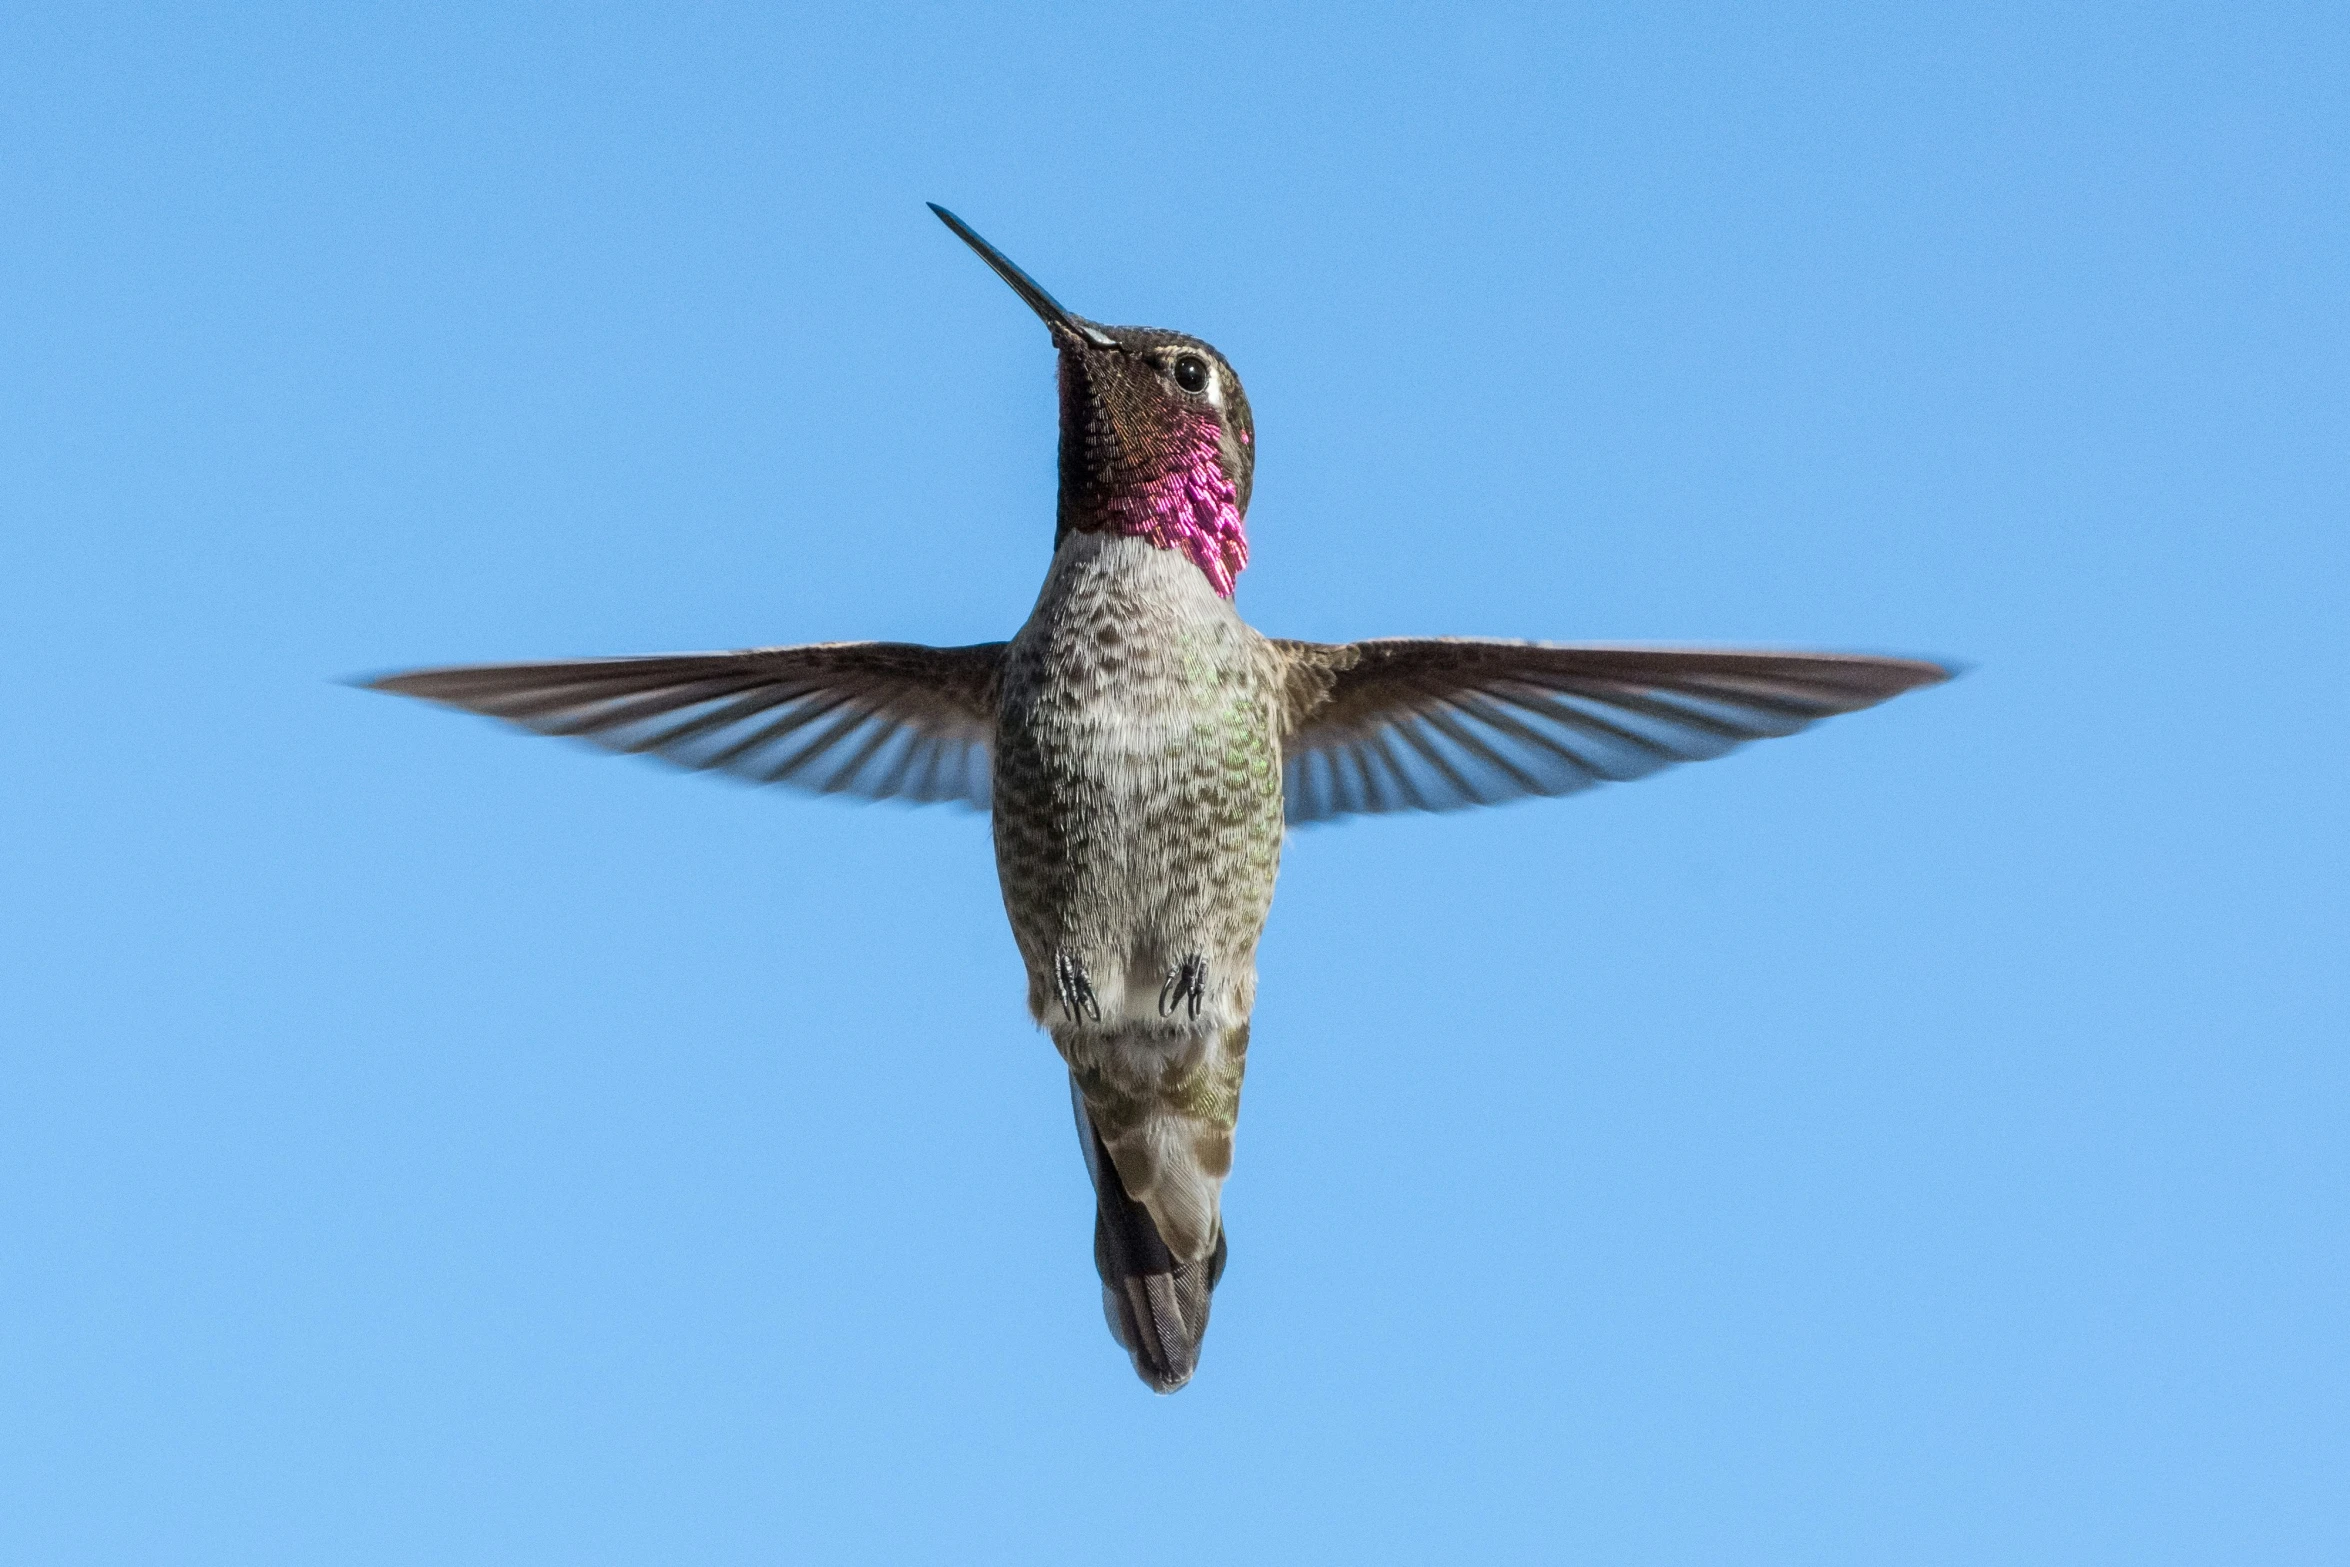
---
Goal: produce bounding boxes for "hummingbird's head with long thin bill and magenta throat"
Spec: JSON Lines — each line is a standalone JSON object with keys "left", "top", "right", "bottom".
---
{"left": 931, "top": 202, "right": 1257, "bottom": 599}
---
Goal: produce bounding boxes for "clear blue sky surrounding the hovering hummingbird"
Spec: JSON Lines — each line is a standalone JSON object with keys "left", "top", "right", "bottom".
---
{"left": 0, "top": 5, "right": 2350, "bottom": 1565}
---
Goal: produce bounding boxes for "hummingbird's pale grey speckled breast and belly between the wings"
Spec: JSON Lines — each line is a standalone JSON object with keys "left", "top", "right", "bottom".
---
{"left": 994, "top": 540, "right": 1283, "bottom": 1027}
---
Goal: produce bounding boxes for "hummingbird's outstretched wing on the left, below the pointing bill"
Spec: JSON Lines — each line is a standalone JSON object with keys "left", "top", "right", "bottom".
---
{"left": 362, "top": 641, "right": 1003, "bottom": 808}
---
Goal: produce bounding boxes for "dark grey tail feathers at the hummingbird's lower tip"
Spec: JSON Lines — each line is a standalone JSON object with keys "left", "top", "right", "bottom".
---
{"left": 1069, "top": 1083, "right": 1224, "bottom": 1393}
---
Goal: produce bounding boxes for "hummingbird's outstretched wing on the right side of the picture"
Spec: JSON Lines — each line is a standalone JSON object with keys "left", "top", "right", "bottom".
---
{"left": 1274, "top": 637, "right": 1951, "bottom": 825}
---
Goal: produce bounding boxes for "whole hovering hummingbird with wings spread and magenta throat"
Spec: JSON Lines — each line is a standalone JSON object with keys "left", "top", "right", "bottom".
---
{"left": 369, "top": 204, "right": 1951, "bottom": 1393}
